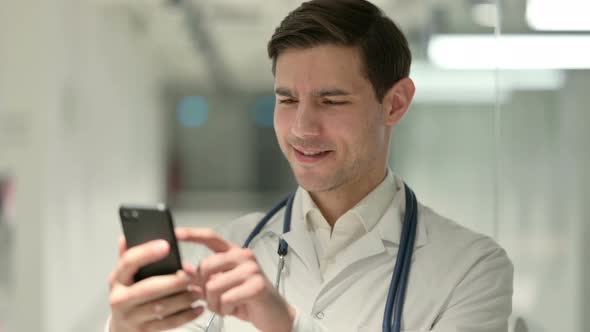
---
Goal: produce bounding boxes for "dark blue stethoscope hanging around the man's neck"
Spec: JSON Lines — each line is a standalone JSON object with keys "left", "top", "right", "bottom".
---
{"left": 205, "top": 183, "right": 418, "bottom": 332}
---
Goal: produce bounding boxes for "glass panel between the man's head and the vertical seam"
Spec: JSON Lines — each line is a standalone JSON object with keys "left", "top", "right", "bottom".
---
{"left": 390, "top": 1, "right": 498, "bottom": 236}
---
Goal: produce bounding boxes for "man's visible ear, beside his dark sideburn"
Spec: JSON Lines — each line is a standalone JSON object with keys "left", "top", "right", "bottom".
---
{"left": 383, "top": 77, "right": 416, "bottom": 127}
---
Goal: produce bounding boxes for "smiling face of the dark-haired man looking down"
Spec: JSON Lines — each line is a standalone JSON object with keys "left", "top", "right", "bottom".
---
{"left": 274, "top": 45, "right": 392, "bottom": 192}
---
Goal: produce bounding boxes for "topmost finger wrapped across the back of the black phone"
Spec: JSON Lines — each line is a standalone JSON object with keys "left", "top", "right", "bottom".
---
{"left": 115, "top": 240, "right": 170, "bottom": 286}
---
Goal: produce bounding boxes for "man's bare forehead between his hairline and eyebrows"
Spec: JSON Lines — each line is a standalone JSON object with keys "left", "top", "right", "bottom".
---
{"left": 275, "top": 45, "right": 370, "bottom": 92}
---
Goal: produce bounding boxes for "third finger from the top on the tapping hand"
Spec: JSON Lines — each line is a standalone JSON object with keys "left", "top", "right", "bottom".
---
{"left": 205, "top": 262, "right": 260, "bottom": 314}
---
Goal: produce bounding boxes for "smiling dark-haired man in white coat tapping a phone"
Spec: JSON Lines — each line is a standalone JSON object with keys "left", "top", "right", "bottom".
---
{"left": 108, "top": 0, "right": 513, "bottom": 332}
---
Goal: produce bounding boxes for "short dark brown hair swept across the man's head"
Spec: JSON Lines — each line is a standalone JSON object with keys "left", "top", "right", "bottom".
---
{"left": 268, "top": 0, "right": 412, "bottom": 101}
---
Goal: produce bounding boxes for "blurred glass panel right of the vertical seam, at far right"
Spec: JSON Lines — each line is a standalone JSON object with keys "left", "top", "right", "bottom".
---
{"left": 496, "top": 0, "right": 590, "bottom": 331}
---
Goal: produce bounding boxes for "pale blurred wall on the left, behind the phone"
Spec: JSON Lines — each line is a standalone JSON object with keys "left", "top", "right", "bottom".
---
{"left": 0, "top": 0, "right": 165, "bottom": 332}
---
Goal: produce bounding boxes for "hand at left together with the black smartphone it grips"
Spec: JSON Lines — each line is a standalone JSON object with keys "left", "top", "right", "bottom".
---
{"left": 109, "top": 202, "right": 204, "bottom": 332}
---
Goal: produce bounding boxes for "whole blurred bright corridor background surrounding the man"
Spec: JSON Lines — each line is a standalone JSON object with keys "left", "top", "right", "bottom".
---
{"left": 0, "top": 0, "right": 590, "bottom": 332}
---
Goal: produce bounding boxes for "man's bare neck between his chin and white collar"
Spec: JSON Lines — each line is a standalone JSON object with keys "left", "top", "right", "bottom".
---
{"left": 310, "top": 167, "right": 387, "bottom": 228}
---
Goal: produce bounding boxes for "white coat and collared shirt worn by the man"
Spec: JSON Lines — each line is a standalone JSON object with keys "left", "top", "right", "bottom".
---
{"left": 110, "top": 175, "right": 513, "bottom": 332}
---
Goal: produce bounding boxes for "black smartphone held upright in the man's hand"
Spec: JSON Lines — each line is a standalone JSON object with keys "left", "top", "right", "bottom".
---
{"left": 119, "top": 204, "right": 182, "bottom": 282}
